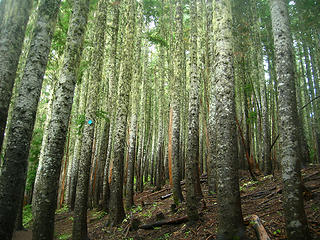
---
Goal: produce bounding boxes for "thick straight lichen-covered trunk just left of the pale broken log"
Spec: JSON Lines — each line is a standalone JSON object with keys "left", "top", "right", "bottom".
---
{"left": 210, "top": 0, "right": 245, "bottom": 239}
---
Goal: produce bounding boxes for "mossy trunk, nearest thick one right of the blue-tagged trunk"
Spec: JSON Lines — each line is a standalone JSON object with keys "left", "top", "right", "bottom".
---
{"left": 109, "top": 0, "right": 135, "bottom": 226}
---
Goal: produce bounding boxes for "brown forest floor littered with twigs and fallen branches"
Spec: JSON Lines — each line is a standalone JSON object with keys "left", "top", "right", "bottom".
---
{"left": 13, "top": 165, "right": 320, "bottom": 240}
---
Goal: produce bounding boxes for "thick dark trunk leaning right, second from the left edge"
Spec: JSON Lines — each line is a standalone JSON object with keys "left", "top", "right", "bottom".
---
{"left": 0, "top": 0, "right": 60, "bottom": 240}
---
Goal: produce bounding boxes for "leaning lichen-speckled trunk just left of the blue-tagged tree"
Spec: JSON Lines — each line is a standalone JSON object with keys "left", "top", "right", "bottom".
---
{"left": 33, "top": 1, "right": 89, "bottom": 240}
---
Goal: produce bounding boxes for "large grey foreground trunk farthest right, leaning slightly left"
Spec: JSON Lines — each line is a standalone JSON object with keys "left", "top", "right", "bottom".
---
{"left": 270, "top": 0, "right": 310, "bottom": 239}
